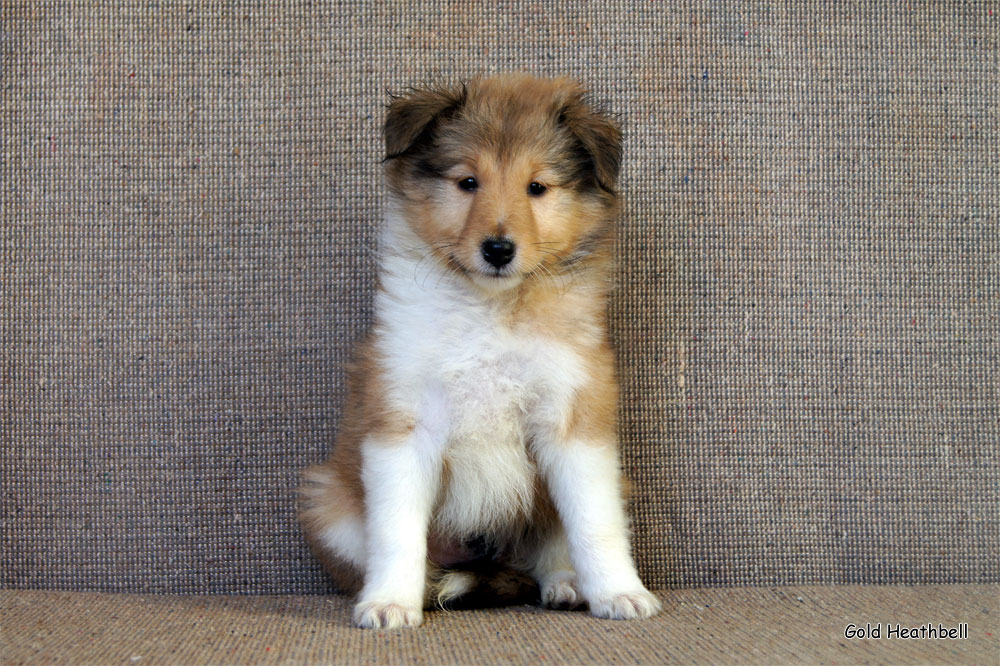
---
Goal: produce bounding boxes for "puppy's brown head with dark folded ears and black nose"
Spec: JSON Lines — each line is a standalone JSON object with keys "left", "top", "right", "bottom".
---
{"left": 385, "top": 75, "right": 621, "bottom": 291}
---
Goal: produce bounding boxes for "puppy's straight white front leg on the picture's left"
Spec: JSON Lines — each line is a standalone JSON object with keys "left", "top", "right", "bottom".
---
{"left": 354, "top": 429, "right": 441, "bottom": 629}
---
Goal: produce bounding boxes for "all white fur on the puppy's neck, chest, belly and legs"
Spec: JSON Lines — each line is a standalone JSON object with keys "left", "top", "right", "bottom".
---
{"left": 356, "top": 208, "right": 659, "bottom": 628}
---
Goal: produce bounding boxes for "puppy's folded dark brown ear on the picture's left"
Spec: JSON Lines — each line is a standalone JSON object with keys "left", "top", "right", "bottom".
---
{"left": 384, "top": 83, "right": 468, "bottom": 160}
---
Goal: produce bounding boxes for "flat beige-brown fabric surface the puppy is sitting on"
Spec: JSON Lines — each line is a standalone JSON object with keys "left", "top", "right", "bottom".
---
{"left": 0, "top": 586, "right": 1000, "bottom": 666}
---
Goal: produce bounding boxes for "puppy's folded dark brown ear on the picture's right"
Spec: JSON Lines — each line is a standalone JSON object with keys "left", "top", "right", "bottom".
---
{"left": 559, "top": 91, "right": 622, "bottom": 195}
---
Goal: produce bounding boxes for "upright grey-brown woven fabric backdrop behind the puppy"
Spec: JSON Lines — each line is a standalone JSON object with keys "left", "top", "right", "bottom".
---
{"left": 0, "top": 0, "right": 1000, "bottom": 593}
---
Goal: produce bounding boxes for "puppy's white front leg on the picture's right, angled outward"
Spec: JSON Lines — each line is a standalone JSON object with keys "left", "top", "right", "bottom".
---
{"left": 538, "top": 439, "right": 661, "bottom": 620}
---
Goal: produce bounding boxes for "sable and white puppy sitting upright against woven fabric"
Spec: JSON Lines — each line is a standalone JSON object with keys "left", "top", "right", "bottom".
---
{"left": 301, "top": 75, "right": 660, "bottom": 628}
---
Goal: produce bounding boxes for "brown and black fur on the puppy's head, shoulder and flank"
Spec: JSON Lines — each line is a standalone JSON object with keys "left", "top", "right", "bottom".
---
{"left": 301, "top": 76, "right": 621, "bottom": 603}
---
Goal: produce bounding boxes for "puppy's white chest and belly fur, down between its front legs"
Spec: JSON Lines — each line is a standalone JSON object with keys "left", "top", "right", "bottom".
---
{"left": 376, "top": 276, "right": 583, "bottom": 534}
